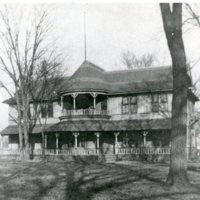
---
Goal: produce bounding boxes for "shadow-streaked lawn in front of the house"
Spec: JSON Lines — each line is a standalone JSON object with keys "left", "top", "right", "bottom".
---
{"left": 0, "top": 161, "right": 200, "bottom": 200}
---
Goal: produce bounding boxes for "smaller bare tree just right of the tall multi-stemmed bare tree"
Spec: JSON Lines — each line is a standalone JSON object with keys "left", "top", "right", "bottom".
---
{"left": 30, "top": 60, "right": 63, "bottom": 158}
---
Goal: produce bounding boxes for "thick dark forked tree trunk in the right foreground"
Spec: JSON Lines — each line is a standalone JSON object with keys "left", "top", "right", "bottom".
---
{"left": 160, "top": 3, "right": 189, "bottom": 188}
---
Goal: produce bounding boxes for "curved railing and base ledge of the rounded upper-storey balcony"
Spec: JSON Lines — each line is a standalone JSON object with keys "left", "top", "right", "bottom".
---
{"left": 60, "top": 108, "right": 110, "bottom": 120}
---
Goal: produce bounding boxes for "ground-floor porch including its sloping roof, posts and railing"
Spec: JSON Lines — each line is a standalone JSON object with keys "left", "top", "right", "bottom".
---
{"left": 2, "top": 119, "right": 170, "bottom": 159}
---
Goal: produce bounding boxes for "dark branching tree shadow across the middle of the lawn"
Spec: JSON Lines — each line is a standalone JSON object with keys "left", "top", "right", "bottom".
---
{"left": 66, "top": 163, "right": 162, "bottom": 200}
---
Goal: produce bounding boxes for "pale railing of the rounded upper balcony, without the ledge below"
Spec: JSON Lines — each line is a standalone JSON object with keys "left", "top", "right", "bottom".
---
{"left": 63, "top": 109, "right": 108, "bottom": 116}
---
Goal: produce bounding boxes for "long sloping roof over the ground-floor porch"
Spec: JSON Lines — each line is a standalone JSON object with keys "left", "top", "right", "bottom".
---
{"left": 47, "top": 118, "right": 171, "bottom": 132}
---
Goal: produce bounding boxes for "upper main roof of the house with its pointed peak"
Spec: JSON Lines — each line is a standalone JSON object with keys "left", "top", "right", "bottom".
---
{"left": 60, "top": 61, "right": 172, "bottom": 94}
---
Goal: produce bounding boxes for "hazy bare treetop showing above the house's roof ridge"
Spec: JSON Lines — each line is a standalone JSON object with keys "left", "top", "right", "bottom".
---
{"left": 122, "top": 51, "right": 155, "bottom": 69}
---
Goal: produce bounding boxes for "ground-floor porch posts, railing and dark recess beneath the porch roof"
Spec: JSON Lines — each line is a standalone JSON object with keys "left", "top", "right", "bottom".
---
{"left": 0, "top": 131, "right": 170, "bottom": 156}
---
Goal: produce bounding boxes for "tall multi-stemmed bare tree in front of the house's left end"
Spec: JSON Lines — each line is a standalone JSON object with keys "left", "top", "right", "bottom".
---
{"left": 0, "top": 7, "right": 62, "bottom": 159}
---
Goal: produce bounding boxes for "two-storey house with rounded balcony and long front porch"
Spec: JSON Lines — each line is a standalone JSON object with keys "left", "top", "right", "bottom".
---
{"left": 1, "top": 61, "right": 197, "bottom": 160}
